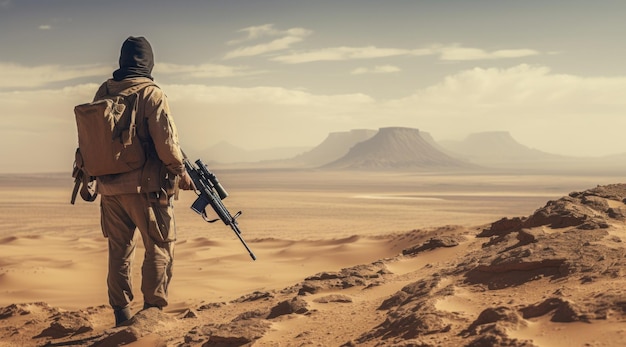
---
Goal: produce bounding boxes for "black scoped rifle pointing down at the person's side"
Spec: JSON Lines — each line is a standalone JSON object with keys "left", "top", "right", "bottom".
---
{"left": 184, "top": 157, "right": 256, "bottom": 260}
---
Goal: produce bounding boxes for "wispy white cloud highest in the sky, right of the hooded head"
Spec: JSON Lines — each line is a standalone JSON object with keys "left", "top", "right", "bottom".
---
{"left": 224, "top": 24, "right": 312, "bottom": 59}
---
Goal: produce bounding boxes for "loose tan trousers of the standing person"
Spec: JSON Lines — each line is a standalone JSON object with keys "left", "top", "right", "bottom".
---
{"left": 100, "top": 194, "right": 176, "bottom": 309}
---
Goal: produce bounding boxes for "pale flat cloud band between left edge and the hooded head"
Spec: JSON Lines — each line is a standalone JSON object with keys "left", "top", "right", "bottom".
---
{"left": 0, "top": 62, "right": 111, "bottom": 89}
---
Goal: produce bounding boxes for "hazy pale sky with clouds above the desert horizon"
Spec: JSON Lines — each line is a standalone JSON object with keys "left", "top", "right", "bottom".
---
{"left": 0, "top": 0, "right": 626, "bottom": 172}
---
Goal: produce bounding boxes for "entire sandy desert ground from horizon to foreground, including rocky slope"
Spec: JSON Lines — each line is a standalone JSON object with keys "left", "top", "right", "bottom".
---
{"left": 0, "top": 170, "right": 626, "bottom": 347}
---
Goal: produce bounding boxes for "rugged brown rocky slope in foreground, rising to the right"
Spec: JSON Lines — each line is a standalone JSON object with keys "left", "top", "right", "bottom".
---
{"left": 0, "top": 184, "right": 626, "bottom": 347}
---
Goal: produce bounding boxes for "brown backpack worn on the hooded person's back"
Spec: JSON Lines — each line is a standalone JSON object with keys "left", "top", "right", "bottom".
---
{"left": 71, "top": 82, "right": 154, "bottom": 204}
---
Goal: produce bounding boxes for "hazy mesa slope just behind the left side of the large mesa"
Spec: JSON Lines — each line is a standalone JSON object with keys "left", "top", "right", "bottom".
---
{"left": 290, "top": 129, "right": 377, "bottom": 167}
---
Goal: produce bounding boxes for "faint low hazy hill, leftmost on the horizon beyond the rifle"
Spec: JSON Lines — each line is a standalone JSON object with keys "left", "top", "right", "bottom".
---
{"left": 201, "top": 141, "right": 309, "bottom": 163}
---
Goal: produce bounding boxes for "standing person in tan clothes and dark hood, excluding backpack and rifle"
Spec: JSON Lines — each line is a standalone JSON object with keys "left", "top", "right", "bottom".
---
{"left": 94, "top": 36, "right": 193, "bottom": 326}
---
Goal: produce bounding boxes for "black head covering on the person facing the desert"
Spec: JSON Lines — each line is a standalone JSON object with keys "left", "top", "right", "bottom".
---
{"left": 113, "top": 36, "right": 154, "bottom": 81}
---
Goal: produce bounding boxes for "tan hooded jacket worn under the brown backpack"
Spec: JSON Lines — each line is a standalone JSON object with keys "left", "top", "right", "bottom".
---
{"left": 94, "top": 77, "right": 185, "bottom": 195}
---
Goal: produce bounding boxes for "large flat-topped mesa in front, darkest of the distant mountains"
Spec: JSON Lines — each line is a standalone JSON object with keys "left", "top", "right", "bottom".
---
{"left": 324, "top": 127, "right": 473, "bottom": 170}
